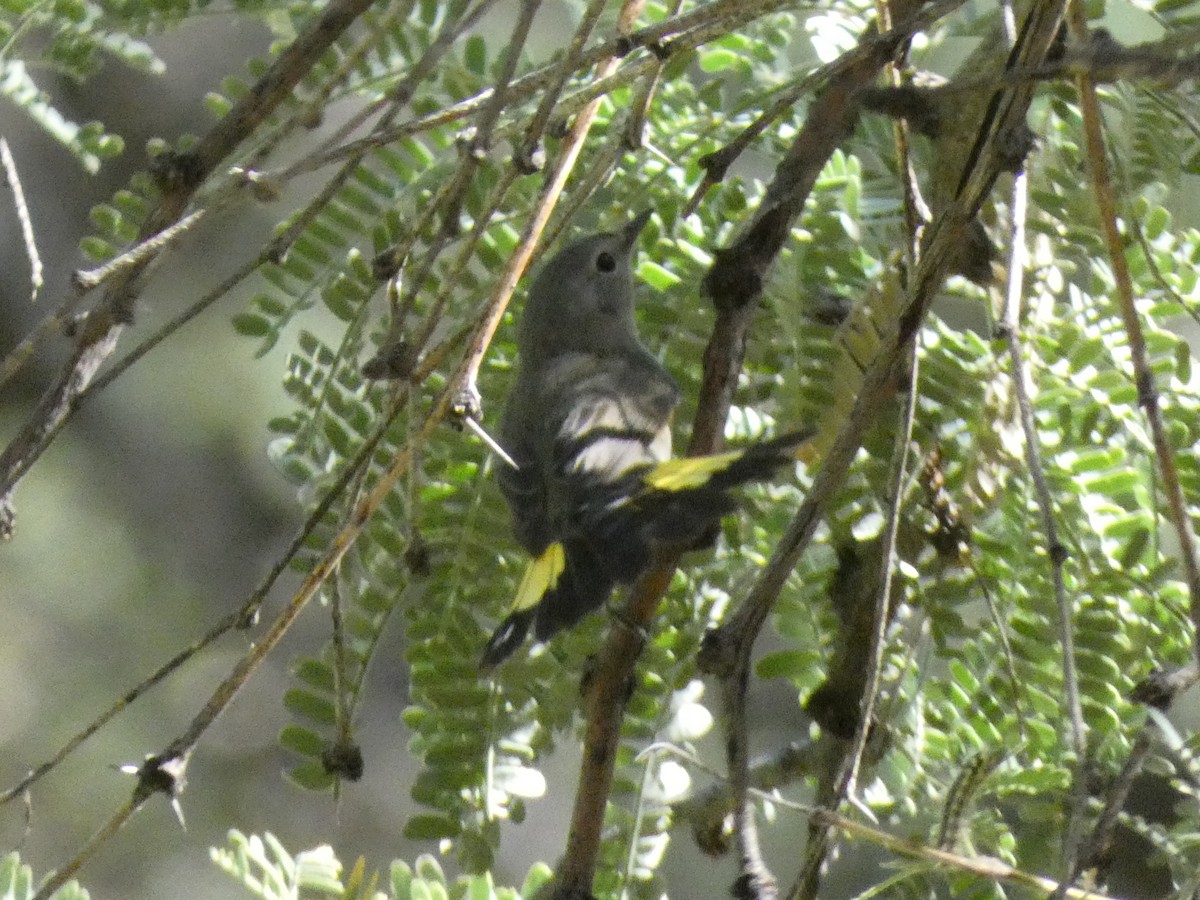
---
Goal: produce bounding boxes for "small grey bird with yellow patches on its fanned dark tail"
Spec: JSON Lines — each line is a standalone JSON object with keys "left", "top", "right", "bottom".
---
{"left": 480, "top": 211, "right": 808, "bottom": 671}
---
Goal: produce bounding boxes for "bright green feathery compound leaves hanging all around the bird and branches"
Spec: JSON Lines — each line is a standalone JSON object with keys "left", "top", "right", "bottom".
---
{"left": 7, "top": 0, "right": 1200, "bottom": 898}
